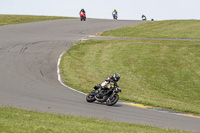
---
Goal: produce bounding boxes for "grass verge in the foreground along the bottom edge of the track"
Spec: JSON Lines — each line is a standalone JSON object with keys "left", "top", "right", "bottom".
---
{"left": 0, "top": 107, "right": 190, "bottom": 133}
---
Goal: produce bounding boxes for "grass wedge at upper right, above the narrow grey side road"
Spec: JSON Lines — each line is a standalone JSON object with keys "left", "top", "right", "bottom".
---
{"left": 102, "top": 20, "right": 200, "bottom": 39}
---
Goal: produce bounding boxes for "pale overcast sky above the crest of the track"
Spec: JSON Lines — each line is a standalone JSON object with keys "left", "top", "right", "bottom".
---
{"left": 0, "top": 0, "right": 200, "bottom": 20}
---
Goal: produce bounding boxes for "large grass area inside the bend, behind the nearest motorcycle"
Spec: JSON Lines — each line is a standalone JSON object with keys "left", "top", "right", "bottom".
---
{"left": 60, "top": 40, "right": 200, "bottom": 114}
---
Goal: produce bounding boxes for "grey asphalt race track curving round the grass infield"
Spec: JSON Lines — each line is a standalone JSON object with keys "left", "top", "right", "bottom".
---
{"left": 0, "top": 19, "right": 200, "bottom": 131}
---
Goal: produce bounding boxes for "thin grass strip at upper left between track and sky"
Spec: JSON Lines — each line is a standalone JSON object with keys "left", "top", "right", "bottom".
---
{"left": 0, "top": 15, "right": 76, "bottom": 26}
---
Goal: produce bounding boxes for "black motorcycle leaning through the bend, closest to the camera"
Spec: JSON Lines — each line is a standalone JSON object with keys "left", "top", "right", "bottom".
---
{"left": 86, "top": 84, "right": 121, "bottom": 106}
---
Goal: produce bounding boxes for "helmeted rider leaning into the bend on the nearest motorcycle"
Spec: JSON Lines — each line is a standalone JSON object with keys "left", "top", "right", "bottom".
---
{"left": 96, "top": 73, "right": 120, "bottom": 98}
